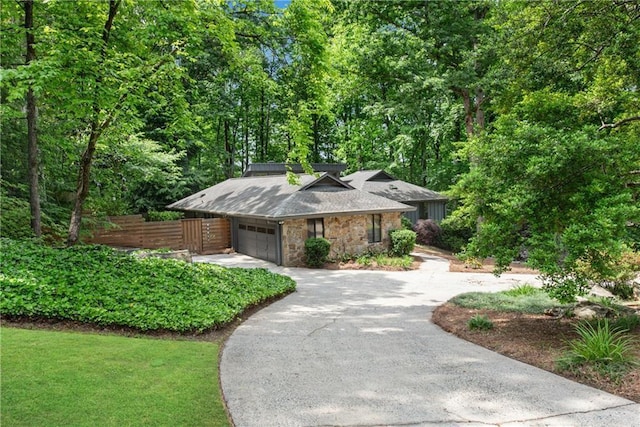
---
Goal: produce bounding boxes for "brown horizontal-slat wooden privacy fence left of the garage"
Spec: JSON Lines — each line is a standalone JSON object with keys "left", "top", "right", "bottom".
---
{"left": 85, "top": 215, "right": 231, "bottom": 254}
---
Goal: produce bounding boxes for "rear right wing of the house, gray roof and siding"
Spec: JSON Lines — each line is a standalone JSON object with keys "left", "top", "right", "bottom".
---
{"left": 342, "top": 170, "right": 447, "bottom": 224}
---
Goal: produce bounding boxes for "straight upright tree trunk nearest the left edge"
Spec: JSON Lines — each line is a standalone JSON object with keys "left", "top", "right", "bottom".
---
{"left": 24, "top": 0, "right": 42, "bottom": 237}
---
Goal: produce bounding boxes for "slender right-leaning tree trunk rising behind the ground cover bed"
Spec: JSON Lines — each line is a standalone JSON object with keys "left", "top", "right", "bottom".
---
{"left": 67, "top": 0, "right": 120, "bottom": 246}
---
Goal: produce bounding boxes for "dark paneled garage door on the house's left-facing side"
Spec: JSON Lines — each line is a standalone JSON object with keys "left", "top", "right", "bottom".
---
{"left": 236, "top": 219, "right": 278, "bottom": 263}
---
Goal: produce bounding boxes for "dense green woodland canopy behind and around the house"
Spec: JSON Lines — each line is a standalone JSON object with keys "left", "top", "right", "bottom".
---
{"left": 0, "top": 0, "right": 640, "bottom": 300}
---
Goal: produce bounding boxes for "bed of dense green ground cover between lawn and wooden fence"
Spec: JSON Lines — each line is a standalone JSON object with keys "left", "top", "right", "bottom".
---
{"left": 0, "top": 239, "right": 295, "bottom": 332}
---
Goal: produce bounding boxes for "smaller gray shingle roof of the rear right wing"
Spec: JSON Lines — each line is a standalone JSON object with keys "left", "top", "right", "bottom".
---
{"left": 342, "top": 170, "right": 447, "bottom": 202}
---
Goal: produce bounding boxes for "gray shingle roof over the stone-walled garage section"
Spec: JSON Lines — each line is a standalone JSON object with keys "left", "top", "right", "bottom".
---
{"left": 168, "top": 173, "right": 415, "bottom": 220}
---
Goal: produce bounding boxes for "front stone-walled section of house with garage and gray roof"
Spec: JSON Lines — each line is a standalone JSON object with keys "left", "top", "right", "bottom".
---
{"left": 168, "top": 172, "right": 416, "bottom": 266}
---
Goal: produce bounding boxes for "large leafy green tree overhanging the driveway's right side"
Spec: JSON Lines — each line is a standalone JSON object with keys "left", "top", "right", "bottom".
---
{"left": 444, "top": 1, "right": 640, "bottom": 299}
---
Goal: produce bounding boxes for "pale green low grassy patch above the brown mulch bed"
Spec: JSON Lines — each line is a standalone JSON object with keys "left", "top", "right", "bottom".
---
{"left": 451, "top": 285, "right": 559, "bottom": 314}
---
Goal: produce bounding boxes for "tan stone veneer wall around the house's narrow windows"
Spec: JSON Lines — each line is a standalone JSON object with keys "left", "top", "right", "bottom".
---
{"left": 282, "top": 212, "right": 402, "bottom": 267}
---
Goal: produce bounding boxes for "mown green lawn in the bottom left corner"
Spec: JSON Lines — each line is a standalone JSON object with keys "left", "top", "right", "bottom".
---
{"left": 0, "top": 328, "right": 229, "bottom": 427}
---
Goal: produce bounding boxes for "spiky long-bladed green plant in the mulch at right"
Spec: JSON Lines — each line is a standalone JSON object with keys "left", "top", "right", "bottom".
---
{"left": 558, "top": 319, "right": 634, "bottom": 372}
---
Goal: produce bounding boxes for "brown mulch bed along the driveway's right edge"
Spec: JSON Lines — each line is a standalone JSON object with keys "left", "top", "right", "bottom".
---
{"left": 432, "top": 303, "right": 640, "bottom": 403}
